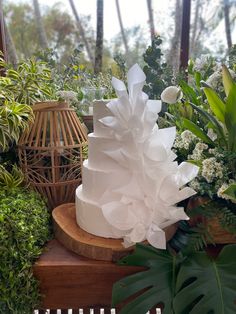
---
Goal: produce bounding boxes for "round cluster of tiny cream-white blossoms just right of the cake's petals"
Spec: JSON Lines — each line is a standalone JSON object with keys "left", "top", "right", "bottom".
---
{"left": 201, "top": 157, "right": 223, "bottom": 183}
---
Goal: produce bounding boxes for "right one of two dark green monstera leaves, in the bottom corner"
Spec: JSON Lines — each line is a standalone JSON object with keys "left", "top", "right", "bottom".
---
{"left": 173, "top": 245, "right": 236, "bottom": 314}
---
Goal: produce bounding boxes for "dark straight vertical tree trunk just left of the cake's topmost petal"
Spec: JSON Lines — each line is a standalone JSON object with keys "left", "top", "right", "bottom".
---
{"left": 94, "top": 0, "right": 103, "bottom": 74}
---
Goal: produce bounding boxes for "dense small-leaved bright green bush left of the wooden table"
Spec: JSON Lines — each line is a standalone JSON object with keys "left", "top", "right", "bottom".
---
{"left": 0, "top": 188, "right": 50, "bottom": 314}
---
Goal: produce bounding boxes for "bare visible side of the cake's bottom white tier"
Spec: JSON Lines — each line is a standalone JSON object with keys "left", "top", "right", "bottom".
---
{"left": 75, "top": 184, "right": 123, "bottom": 239}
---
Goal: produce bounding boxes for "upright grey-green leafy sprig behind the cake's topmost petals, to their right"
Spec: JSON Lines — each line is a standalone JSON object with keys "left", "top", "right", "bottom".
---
{"left": 143, "top": 36, "right": 172, "bottom": 99}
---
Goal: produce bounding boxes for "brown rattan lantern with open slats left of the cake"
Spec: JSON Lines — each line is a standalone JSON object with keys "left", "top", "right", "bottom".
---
{"left": 18, "top": 102, "right": 87, "bottom": 209}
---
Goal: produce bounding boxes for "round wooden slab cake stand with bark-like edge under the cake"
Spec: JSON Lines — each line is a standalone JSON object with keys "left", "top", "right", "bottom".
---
{"left": 52, "top": 203, "right": 177, "bottom": 262}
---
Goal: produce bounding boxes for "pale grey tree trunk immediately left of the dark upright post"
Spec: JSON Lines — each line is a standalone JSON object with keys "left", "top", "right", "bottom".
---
{"left": 167, "top": 0, "right": 182, "bottom": 72}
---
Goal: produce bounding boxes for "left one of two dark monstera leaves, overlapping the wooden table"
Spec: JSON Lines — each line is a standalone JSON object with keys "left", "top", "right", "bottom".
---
{"left": 112, "top": 244, "right": 176, "bottom": 314}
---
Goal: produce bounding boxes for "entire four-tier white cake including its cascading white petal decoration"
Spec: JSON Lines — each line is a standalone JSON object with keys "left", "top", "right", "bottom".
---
{"left": 76, "top": 65, "right": 198, "bottom": 248}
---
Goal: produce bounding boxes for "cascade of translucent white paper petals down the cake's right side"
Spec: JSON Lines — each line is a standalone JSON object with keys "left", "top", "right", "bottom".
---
{"left": 100, "top": 64, "right": 198, "bottom": 249}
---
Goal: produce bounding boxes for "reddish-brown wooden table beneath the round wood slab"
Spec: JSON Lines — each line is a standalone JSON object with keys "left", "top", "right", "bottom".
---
{"left": 34, "top": 240, "right": 142, "bottom": 309}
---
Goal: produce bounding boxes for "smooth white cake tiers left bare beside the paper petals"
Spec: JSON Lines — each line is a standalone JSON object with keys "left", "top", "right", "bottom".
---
{"left": 76, "top": 100, "right": 129, "bottom": 238}
